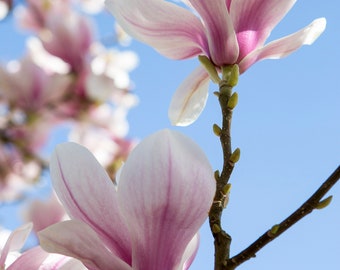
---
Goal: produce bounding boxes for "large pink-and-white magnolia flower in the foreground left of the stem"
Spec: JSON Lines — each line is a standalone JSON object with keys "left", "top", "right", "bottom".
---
{"left": 38, "top": 130, "right": 215, "bottom": 270}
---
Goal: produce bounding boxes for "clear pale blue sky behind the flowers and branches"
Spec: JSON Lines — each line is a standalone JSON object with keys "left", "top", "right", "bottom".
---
{"left": 0, "top": 0, "right": 340, "bottom": 270}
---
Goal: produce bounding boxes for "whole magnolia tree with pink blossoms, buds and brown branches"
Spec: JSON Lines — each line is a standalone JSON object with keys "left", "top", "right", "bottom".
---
{"left": 0, "top": 0, "right": 340, "bottom": 270}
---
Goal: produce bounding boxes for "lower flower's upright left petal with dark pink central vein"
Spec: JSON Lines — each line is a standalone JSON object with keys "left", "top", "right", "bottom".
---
{"left": 50, "top": 143, "right": 131, "bottom": 262}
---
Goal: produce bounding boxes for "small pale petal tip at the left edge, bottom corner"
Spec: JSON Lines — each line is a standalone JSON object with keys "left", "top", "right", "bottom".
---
{"left": 0, "top": 223, "right": 33, "bottom": 269}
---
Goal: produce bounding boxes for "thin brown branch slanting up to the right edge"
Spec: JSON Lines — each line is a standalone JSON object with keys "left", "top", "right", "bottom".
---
{"left": 224, "top": 166, "right": 340, "bottom": 270}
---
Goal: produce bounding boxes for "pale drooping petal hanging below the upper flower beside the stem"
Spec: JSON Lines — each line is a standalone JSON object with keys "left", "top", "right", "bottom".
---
{"left": 168, "top": 66, "right": 210, "bottom": 126}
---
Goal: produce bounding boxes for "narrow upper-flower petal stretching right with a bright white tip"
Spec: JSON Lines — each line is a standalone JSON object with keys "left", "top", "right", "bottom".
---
{"left": 239, "top": 18, "right": 326, "bottom": 73}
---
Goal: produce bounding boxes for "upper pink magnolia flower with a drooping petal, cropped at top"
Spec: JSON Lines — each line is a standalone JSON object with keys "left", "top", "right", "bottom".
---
{"left": 106, "top": 0, "right": 326, "bottom": 125}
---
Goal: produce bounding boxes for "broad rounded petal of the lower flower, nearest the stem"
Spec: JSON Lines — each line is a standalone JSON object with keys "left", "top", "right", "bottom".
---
{"left": 118, "top": 130, "right": 215, "bottom": 270}
